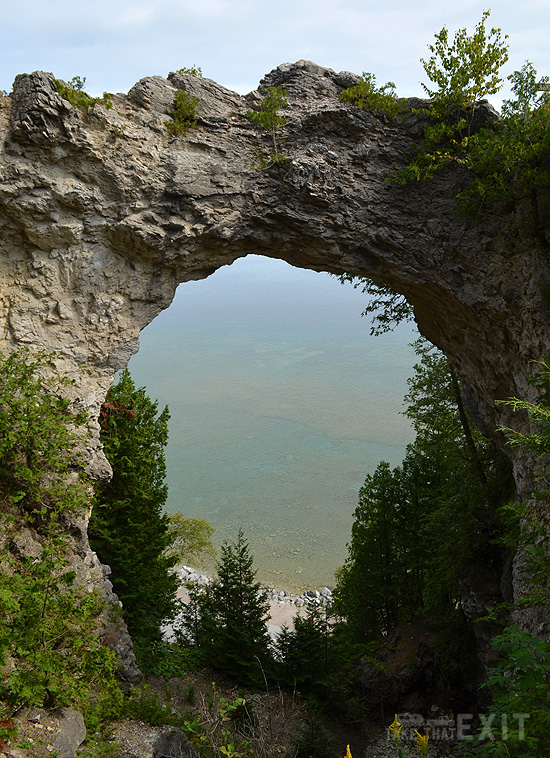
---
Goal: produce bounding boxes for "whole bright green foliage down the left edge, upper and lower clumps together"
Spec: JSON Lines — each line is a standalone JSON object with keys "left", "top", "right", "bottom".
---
{"left": 0, "top": 351, "right": 122, "bottom": 711}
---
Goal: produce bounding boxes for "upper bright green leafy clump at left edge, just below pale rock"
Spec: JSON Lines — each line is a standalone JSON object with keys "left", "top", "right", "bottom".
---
{"left": 0, "top": 351, "right": 89, "bottom": 518}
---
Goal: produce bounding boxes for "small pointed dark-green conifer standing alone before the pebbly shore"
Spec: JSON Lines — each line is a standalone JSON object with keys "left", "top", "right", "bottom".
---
{"left": 181, "top": 531, "right": 271, "bottom": 684}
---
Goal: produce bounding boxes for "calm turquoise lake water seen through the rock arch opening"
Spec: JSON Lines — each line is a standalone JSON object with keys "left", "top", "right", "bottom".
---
{"left": 126, "top": 256, "right": 417, "bottom": 589}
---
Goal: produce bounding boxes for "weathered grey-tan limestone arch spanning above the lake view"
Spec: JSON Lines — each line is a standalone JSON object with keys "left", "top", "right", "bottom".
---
{"left": 0, "top": 61, "right": 550, "bottom": 624}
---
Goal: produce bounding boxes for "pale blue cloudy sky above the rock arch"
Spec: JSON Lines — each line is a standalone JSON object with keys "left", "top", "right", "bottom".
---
{"left": 0, "top": 0, "right": 550, "bottom": 104}
